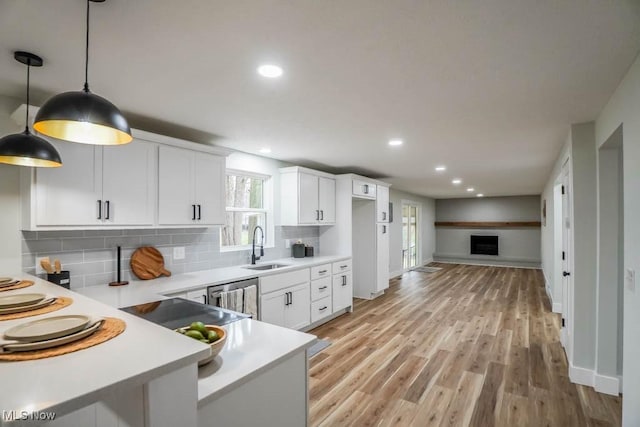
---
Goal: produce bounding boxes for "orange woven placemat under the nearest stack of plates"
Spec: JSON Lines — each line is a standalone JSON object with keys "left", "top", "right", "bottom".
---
{"left": 0, "top": 317, "right": 127, "bottom": 362}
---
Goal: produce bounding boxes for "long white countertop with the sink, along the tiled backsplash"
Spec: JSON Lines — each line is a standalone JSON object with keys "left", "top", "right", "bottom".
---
{"left": 77, "top": 255, "right": 351, "bottom": 307}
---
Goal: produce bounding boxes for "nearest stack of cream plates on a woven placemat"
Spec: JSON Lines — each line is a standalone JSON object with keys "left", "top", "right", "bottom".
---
{"left": 0, "top": 315, "right": 103, "bottom": 353}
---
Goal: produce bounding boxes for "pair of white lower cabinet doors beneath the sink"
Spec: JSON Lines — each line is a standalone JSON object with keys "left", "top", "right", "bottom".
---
{"left": 260, "top": 282, "right": 311, "bottom": 329}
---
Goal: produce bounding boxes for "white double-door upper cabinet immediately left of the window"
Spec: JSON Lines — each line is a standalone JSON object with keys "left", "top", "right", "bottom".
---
{"left": 158, "top": 146, "right": 225, "bottom": 226}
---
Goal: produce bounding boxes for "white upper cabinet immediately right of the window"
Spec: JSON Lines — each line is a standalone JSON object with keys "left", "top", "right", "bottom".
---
{"left": 280, "top": 167, "right": 336, "bottom": 225}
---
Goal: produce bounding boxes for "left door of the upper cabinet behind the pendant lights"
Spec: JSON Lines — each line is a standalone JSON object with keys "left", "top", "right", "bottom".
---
{"left": 35, "top": 141, "right": 102, "bottom": 226}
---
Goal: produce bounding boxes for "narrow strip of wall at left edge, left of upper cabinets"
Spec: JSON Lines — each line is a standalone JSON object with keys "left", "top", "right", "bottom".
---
{"left": 0, "top": 96, "right": 23, "bottom": 274}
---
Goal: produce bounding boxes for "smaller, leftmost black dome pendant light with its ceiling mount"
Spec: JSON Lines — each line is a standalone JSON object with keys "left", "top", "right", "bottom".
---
{"left": 0, "top": 52, "right": 62, "bottom": 168}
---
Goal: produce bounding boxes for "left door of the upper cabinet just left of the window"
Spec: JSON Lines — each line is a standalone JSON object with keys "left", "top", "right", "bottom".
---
{"left": 158, "top": 145, "right": 195, "bottom": 225}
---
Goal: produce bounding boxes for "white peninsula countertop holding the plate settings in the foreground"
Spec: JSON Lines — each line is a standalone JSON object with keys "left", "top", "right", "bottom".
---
{"left": 0, "top": 274, "right": 210, "bottom": 426}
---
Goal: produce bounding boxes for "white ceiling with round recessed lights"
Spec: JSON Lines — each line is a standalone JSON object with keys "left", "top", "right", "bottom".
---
{"left": 0, "top": 0, "right": 640, "bottom": 197}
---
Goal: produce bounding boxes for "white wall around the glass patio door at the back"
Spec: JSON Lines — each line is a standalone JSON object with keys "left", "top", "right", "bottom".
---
{"left": 389, "top": 187, "right": 436, "bottom": 277}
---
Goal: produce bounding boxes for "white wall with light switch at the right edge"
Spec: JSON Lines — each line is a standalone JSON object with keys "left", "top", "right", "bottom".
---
{"left": 595, "top": 51, "right": 640, "bottom": 427}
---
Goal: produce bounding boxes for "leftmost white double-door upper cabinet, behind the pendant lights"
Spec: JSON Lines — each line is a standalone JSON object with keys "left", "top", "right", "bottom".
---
{"left": 23, "top": 140, "right": 156, "bottom": 229}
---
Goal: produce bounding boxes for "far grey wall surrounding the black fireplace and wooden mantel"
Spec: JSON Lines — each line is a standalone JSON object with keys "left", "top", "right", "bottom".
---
{"left": 434, "top": 196, "right": 541, "bottom": 267}
